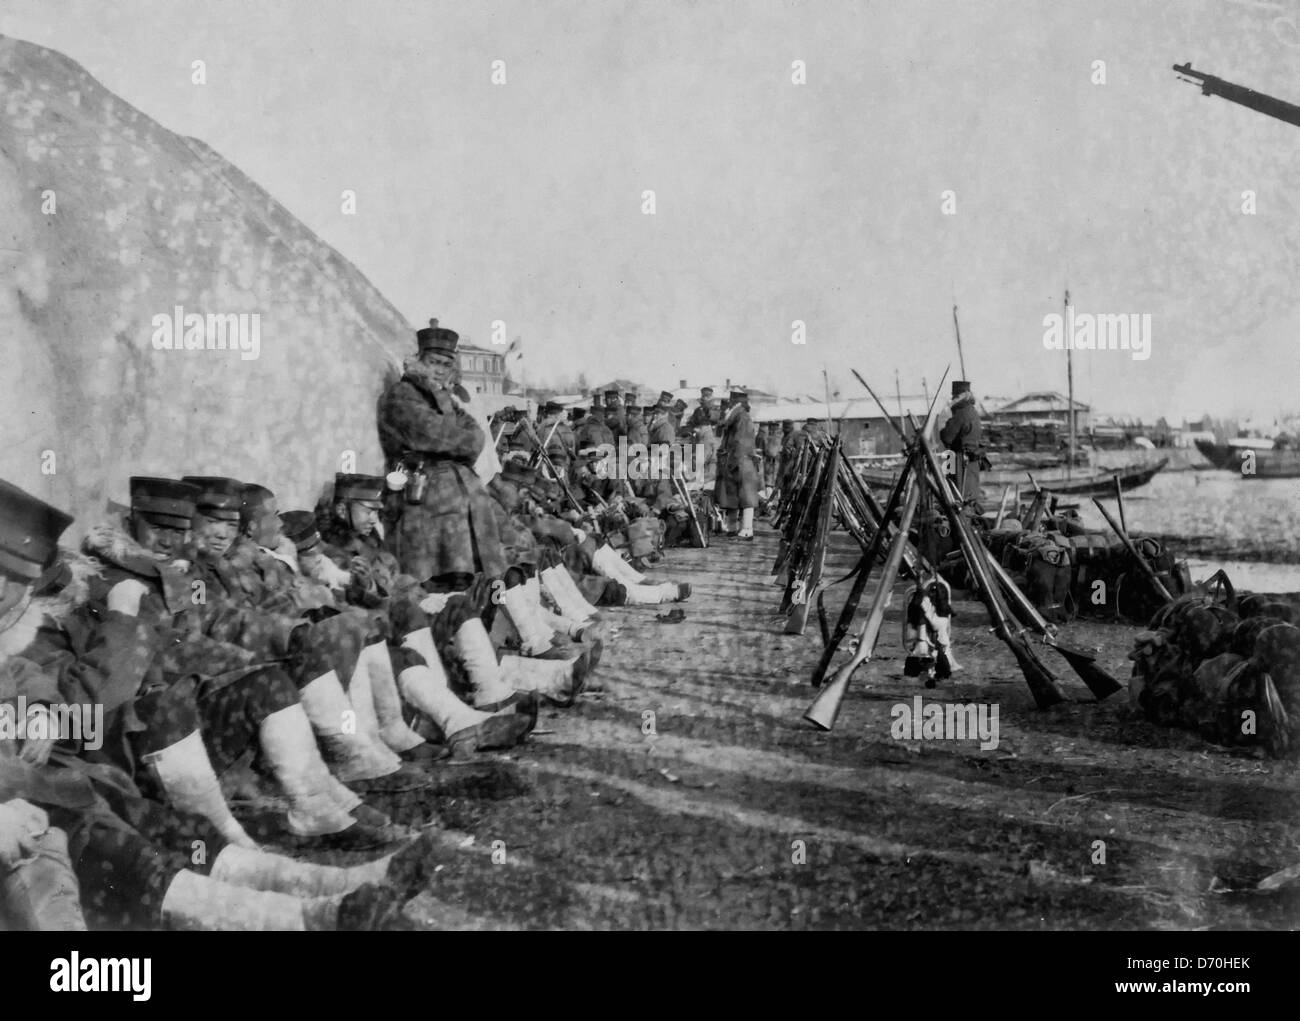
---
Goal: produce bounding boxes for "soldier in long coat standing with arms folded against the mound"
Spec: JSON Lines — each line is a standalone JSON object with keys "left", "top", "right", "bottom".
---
{"left": 380, "top": 320, "right": 508, "bottom": 589}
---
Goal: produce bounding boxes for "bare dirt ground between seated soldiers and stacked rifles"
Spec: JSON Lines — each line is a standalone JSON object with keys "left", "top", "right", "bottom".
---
{"left": 269, "top": 529, "right": 1300, "bottom": 929}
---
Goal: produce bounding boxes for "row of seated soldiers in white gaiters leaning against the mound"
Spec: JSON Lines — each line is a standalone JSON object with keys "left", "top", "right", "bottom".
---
{"left": 0, "top": 462, "right": 689, "bottom": 930}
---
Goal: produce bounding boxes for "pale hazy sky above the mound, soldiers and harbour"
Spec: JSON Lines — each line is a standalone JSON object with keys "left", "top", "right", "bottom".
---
{"left": 0, "top": 0, "right": 1300, "bottom": 416}
